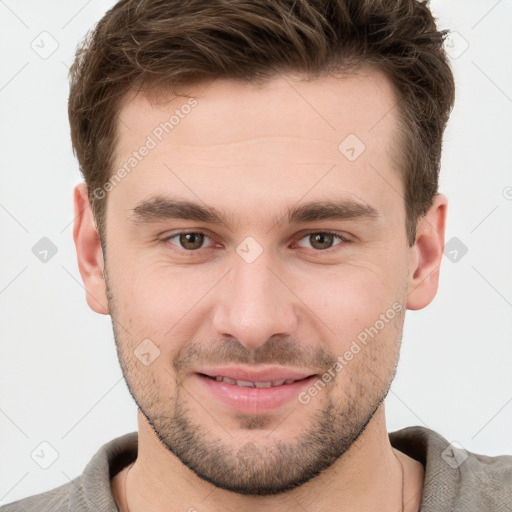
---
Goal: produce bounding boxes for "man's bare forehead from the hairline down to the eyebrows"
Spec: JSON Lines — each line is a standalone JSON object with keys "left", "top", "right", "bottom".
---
{"left": 110, "top": 68, "right": 402, "bottom": 229}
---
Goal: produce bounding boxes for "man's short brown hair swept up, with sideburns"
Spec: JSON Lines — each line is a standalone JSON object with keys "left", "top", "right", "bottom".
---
{"left": 68, "top": 0, "right": 455, "bottom": 246}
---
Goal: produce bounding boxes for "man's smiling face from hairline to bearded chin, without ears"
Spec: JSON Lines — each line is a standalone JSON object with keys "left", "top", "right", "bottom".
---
{"left": 105, "top": 71, "right": 409, "bottom": 494}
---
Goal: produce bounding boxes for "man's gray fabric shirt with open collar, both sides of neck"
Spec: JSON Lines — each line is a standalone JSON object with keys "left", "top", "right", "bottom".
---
{"left": 0, "top": 426, "right": 512, "bottom": 512}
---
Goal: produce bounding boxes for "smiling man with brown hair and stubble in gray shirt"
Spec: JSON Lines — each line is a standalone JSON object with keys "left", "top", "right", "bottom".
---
{"left": 1, "top": 0, "right": 512, "bottom": 512}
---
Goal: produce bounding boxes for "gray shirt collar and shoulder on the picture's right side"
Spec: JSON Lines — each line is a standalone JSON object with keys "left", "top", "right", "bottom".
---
{"left": 389, "top": 426, "right": 512, "bottom": 512}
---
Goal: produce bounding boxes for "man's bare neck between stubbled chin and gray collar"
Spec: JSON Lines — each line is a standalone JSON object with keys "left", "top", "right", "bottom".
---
{"left": 117, "top": 405, "right": 424, "bottom": 512}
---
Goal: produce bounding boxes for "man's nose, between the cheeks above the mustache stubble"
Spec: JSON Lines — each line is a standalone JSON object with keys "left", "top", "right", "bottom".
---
{"left": 213, "top": 247, "right": 299, "bottom": 349}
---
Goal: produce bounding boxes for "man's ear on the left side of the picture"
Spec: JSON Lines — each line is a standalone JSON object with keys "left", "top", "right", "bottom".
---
{"left": 73, "top": 183, "right": 109, "bottom": 315}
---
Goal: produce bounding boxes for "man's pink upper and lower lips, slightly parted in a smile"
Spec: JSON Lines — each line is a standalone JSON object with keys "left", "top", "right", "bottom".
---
{"left": 195, "top": 367, "right": 318, "bottom": 414}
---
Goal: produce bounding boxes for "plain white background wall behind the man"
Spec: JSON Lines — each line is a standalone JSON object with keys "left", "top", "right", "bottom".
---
{"left": 0, "top": 0, "right": 512, "bottom": 503}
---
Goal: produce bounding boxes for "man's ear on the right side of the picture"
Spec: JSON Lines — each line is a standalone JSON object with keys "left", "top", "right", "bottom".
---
{"left": 407, "top": 194, "right": 448, "bottom": 310}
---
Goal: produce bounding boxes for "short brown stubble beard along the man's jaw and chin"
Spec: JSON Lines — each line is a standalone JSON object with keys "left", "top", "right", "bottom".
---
{"left": 107, "top": 266, "right": 398, "bottom": 496}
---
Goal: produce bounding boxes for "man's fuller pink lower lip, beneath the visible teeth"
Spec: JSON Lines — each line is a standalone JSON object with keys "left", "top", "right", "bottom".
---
{"left": 196, "top": 374, "right": 317, "bottom": 414}
